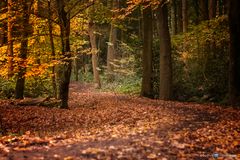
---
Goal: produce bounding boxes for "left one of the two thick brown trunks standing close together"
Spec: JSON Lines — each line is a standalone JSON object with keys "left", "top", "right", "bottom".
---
{"left": 141, "top": 3, "right": 153, "bottom": 98}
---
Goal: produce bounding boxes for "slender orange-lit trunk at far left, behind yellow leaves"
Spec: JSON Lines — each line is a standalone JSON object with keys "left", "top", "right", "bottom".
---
{"left": 7, "top": 0, "right": 13, "bottom": 78}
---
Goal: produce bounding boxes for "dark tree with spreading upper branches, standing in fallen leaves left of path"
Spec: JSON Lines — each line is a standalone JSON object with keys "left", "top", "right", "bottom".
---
{"left": 33, "top": 0, "right": 94, "bottom": 108}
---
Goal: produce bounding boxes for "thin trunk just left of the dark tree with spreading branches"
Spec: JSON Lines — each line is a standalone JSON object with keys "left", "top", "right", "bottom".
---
{"left": 48, "top": 1, "right": 57, "bottom": 98}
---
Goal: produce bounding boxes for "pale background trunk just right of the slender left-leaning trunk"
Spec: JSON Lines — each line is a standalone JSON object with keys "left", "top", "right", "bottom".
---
{"left": 107, "top": 0, "right": 119, "bottom": 81}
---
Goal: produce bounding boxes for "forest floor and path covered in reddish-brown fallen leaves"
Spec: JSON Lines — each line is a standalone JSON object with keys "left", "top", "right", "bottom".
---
{"left": 0, "top": 82, "right": 240, "bottom": 160}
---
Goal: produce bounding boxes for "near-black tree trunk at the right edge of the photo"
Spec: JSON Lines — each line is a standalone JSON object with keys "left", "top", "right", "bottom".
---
{"left": 228, "top": 0, "right": 240, "bottom": 105}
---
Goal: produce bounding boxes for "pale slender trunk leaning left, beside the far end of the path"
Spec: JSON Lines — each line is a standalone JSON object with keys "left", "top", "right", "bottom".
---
{"left": 88, "top": 22, "right": 101, "bottom": 88}
